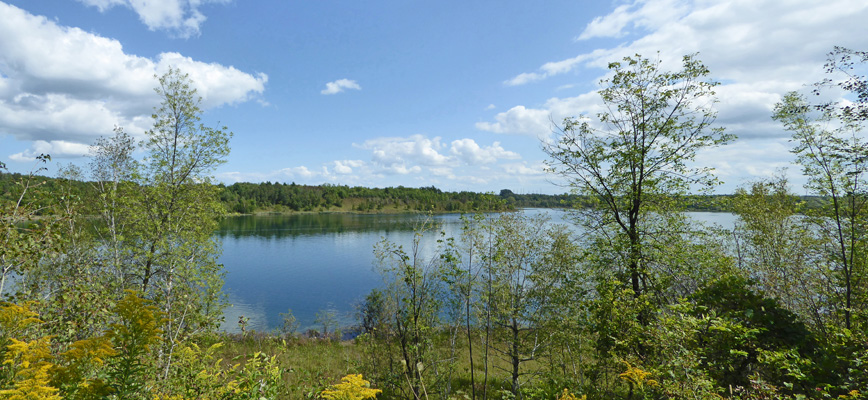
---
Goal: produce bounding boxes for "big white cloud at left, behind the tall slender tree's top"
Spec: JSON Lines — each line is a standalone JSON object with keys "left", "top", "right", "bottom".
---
{"left": 0, "top": 3, "right": 268, "bottom": 161}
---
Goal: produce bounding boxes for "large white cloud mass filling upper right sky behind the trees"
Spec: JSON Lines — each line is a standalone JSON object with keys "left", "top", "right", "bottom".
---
{"left": 484, "top": 0, "right": 868, "bottom": 191}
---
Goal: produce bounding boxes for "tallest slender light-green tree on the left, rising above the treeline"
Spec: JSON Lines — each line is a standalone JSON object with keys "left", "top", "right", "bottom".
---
{"left": 142, "top": 69, "right": 232, "bottom": 342}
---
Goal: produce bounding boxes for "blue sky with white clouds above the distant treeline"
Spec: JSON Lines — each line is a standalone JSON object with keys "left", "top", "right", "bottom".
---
{"left": 0, "top": 0, "right": 868, "bottom": 193}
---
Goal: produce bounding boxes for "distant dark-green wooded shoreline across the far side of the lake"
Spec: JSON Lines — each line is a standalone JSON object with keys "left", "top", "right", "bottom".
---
{"left": 0, "top": 172, "right": 825, "bottom": 216}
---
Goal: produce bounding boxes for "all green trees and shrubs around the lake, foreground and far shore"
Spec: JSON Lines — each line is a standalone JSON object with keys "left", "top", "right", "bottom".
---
{"left": 0, "top": 48, "right": 868, "bottom": 400}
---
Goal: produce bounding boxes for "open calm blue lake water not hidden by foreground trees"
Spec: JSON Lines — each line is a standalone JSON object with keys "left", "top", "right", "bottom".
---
{"left": 215, "top": 209, "right": 734, "bottom": 332}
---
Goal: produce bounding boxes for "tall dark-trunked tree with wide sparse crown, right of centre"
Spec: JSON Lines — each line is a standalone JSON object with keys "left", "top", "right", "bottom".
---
{"left": 544, "top": 55, "right": 734, "bottom": 298}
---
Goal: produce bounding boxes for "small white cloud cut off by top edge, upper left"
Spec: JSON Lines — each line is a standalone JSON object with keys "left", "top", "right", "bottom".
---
{"left": 79, "top": 0, "right": 228, "bottom": 38}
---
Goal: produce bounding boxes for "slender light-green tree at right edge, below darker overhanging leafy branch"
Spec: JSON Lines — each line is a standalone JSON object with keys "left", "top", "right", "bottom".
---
{"left": 775, "top": 93, "right": 868, "bottom": 329}
